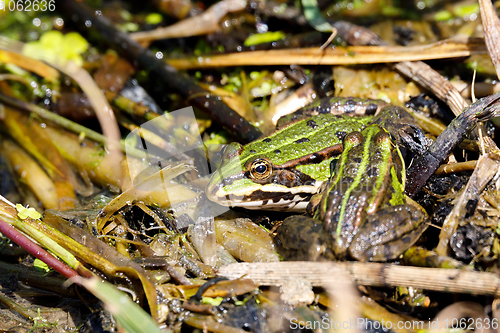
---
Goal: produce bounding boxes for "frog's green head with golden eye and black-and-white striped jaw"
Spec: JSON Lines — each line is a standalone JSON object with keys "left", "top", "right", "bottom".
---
{"left": 205, "top": 143, "right": 321, "bottom": 211}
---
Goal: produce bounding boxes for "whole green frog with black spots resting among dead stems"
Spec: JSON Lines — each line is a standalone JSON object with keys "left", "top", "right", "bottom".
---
{"left": 206, "top": 99, "right": 427, "bottom": 261}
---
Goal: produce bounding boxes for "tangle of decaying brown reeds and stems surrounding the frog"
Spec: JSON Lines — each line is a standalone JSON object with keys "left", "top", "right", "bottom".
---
{"left": 0, "top": 0, "right": 500, "bottom": 333}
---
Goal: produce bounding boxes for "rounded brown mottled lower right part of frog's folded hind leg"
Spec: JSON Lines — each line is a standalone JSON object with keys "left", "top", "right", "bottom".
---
{"left": 349, "top": 204, "right": 428, "bottom": 261}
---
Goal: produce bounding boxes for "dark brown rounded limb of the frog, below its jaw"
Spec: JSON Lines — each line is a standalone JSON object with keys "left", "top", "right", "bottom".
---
{"left": 274, "top": 215, "right": 334, "bottom": 261}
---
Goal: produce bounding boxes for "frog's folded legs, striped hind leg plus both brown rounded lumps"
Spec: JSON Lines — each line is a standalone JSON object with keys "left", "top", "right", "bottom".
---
{"left": 276, "top": 101, "right": 428, "bottom": 261}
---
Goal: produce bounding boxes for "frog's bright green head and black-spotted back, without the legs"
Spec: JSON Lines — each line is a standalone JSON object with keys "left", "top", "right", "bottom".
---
{"left": 206, "top": 98, "right": 386, "bottom": 211}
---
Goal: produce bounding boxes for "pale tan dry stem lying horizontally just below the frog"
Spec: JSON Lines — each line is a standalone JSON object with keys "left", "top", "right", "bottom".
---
{"left": 217, "top": 261, "right": 500, "bottom": 297}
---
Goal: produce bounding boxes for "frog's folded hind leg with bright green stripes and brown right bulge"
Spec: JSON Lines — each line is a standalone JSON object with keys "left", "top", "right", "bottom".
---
{"left": 314, "top": 125, "right": 427, "bottom": 261}
